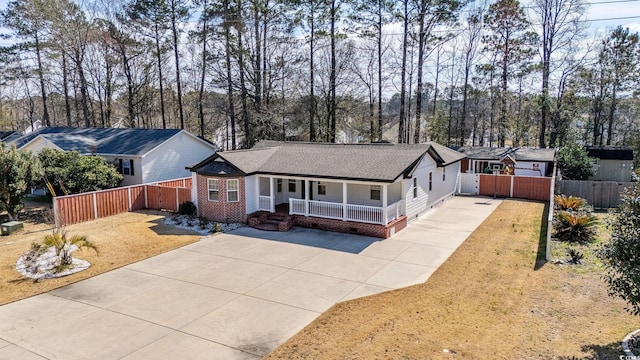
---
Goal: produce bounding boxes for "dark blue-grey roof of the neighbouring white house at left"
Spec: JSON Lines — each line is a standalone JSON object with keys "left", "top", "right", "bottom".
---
{"left": 9, "top": 127, "right": 215, "bottom": 156}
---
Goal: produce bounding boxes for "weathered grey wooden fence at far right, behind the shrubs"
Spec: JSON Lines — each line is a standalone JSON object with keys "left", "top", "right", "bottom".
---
{"left": 556, "top": 180, "right": 633, "bottom": 208}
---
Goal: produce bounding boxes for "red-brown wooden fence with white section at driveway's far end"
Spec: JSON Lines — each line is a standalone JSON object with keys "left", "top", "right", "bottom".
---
{"left": 459, "top": 173, "right": 553, "bottom": 201}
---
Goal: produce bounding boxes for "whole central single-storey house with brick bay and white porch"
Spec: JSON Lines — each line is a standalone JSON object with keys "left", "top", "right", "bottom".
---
{"left": 190, "top": 141, "right": 465, "bottom": 237}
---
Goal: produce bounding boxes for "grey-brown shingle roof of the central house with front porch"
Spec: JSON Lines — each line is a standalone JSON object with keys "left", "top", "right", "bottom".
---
{"left": 190, "top": 141, "right": 465, "bottom": 182}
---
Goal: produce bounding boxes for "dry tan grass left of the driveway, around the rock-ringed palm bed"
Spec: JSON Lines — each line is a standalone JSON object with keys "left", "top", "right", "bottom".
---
{"left": 0, "top": 211, "right": 200, "bottom": 305}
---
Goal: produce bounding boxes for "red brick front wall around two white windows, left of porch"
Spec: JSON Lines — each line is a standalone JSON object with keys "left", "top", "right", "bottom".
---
{"left": 197, "top": 175, "right": 247, "bottom": 223}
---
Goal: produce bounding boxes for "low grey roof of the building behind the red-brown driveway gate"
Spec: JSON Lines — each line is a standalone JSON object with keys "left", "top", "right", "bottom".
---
{"left": 458, "top": 146, "right": 556, "bottom": 162}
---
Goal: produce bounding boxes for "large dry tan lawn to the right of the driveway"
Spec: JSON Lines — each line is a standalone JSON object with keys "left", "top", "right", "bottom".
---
{"left": 267, "top": 200, "right": 640, "bottom": 359}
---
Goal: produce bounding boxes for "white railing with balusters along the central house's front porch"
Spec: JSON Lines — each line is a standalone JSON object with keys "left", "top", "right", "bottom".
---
{"left": 289, "top": 199, "right": 404, "bottom": 225}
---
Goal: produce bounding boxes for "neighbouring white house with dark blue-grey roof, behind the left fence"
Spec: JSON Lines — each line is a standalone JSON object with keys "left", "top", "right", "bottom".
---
{"left": 8, "top": 127, "right": 217, "bottom": 186}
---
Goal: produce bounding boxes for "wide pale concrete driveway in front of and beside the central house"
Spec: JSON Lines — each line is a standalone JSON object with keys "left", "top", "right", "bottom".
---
{"left": 0, "top": 197, "right": 500, "bottom": 360}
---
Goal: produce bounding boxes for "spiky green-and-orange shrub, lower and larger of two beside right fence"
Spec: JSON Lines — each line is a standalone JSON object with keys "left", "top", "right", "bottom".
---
{"left": 553, "top": 211, "right": 599, "bottom": 243}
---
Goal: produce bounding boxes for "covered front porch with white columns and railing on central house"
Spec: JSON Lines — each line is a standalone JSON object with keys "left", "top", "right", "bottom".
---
{"left": 258, "top": 176, "right": 405, "bottom": 225}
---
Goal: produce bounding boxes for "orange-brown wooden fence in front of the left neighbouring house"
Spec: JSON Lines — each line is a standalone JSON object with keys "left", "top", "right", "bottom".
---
{"left": 53, "top": 178, "right": 191, "bottom": 227}
